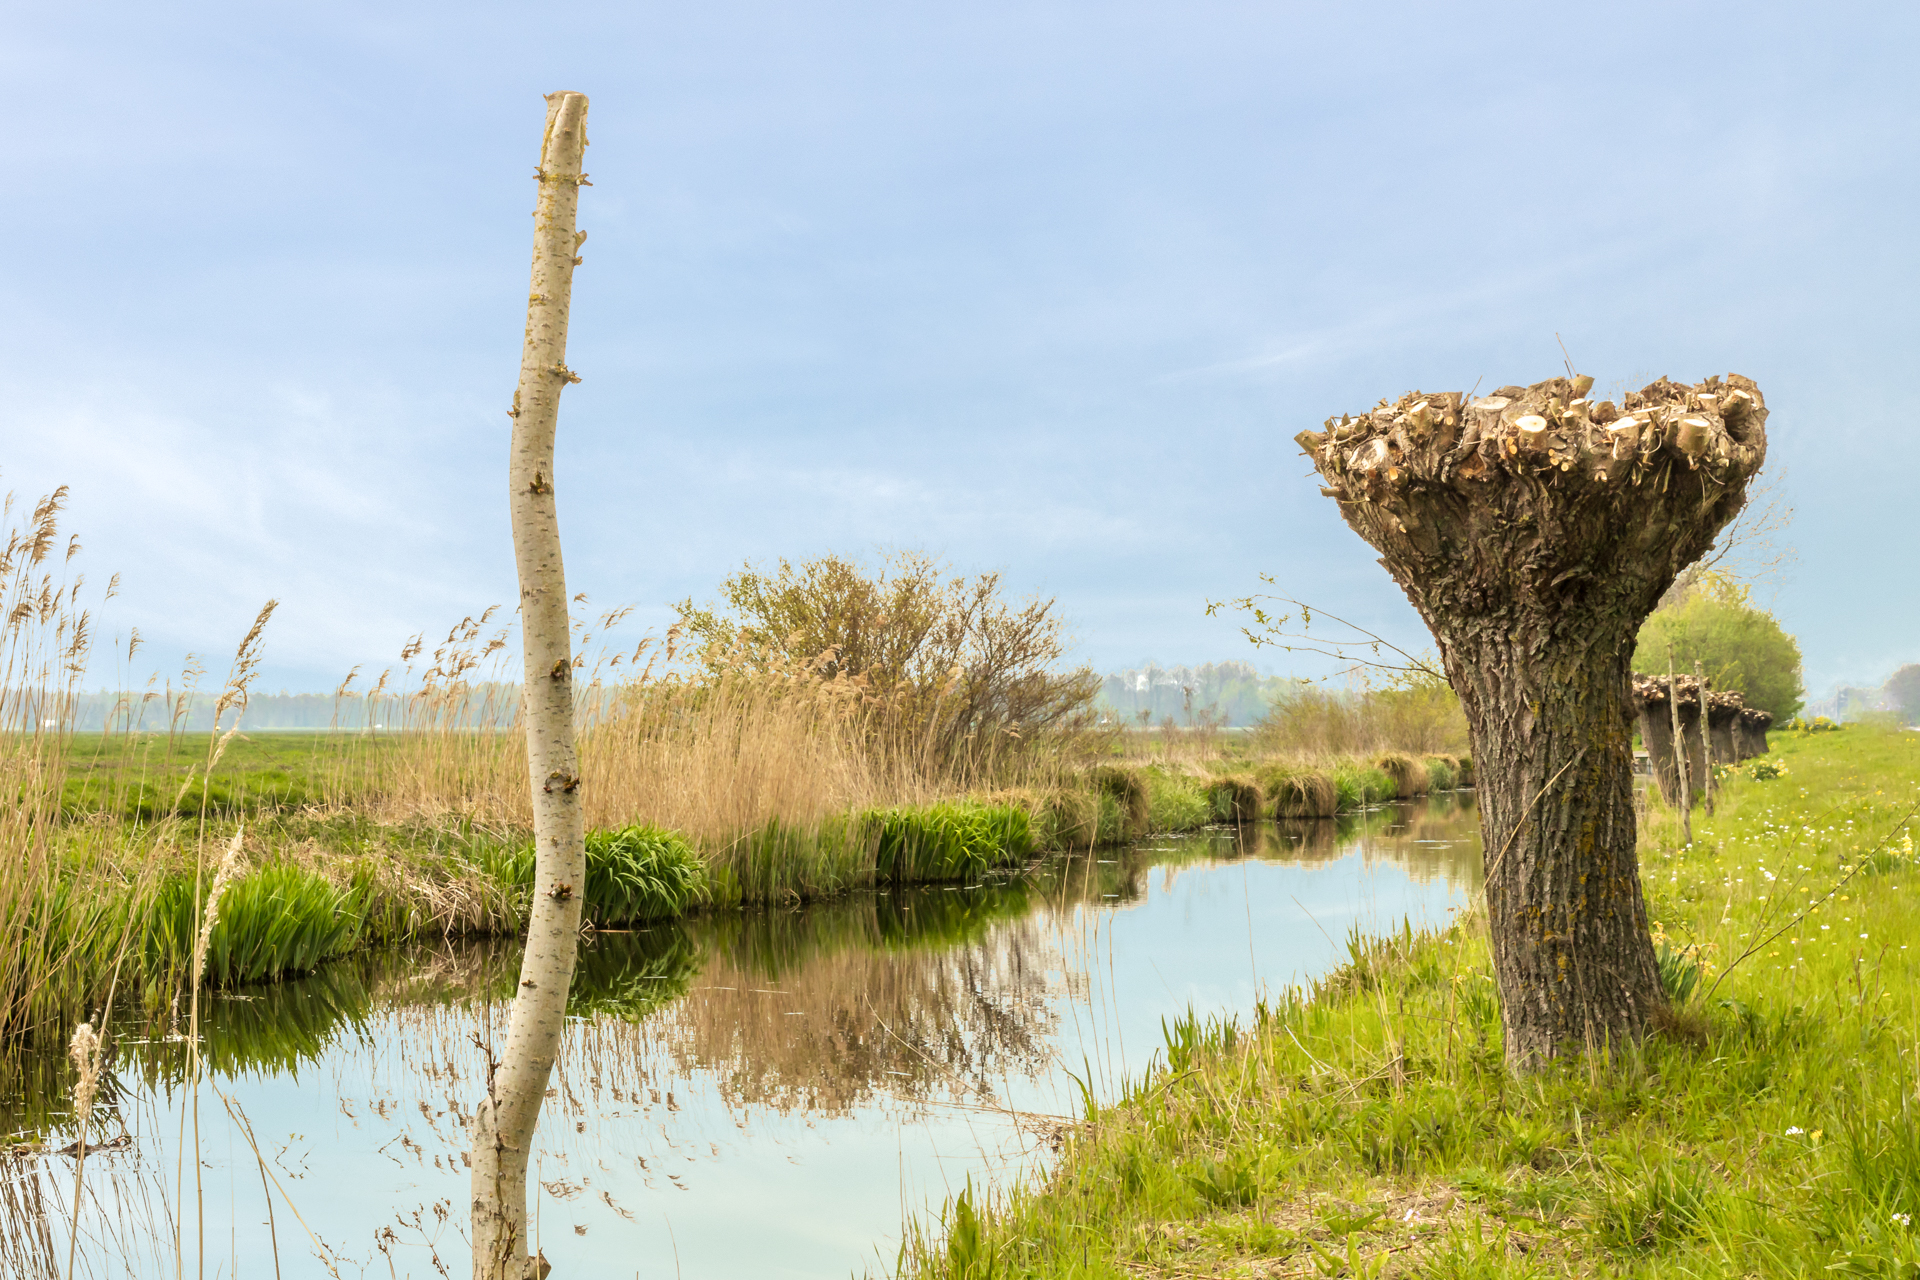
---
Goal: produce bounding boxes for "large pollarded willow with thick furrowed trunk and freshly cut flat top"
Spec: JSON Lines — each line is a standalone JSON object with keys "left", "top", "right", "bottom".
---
{"left": 1296, "top": 374, "right": 1766, "bottom": 1069}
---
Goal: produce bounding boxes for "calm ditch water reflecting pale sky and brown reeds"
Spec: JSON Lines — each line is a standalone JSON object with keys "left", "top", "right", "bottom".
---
{"left": 0, "top": 796, "right": 1480, "bottom": 1280}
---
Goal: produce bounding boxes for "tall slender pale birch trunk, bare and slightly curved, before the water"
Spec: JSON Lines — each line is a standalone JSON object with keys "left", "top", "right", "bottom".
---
{"left": 468, "top": 92, "right": 588, "bottom": 1280}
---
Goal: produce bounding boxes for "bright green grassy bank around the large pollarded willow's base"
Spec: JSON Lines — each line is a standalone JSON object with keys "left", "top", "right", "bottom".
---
{"left": 900, "top": 729, "right": 1920, "bottom": 1280}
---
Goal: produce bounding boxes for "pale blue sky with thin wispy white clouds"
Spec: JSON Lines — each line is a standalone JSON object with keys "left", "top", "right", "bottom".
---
{"left": 0, "top": 0, "right": 1920, "bottom": 695}
